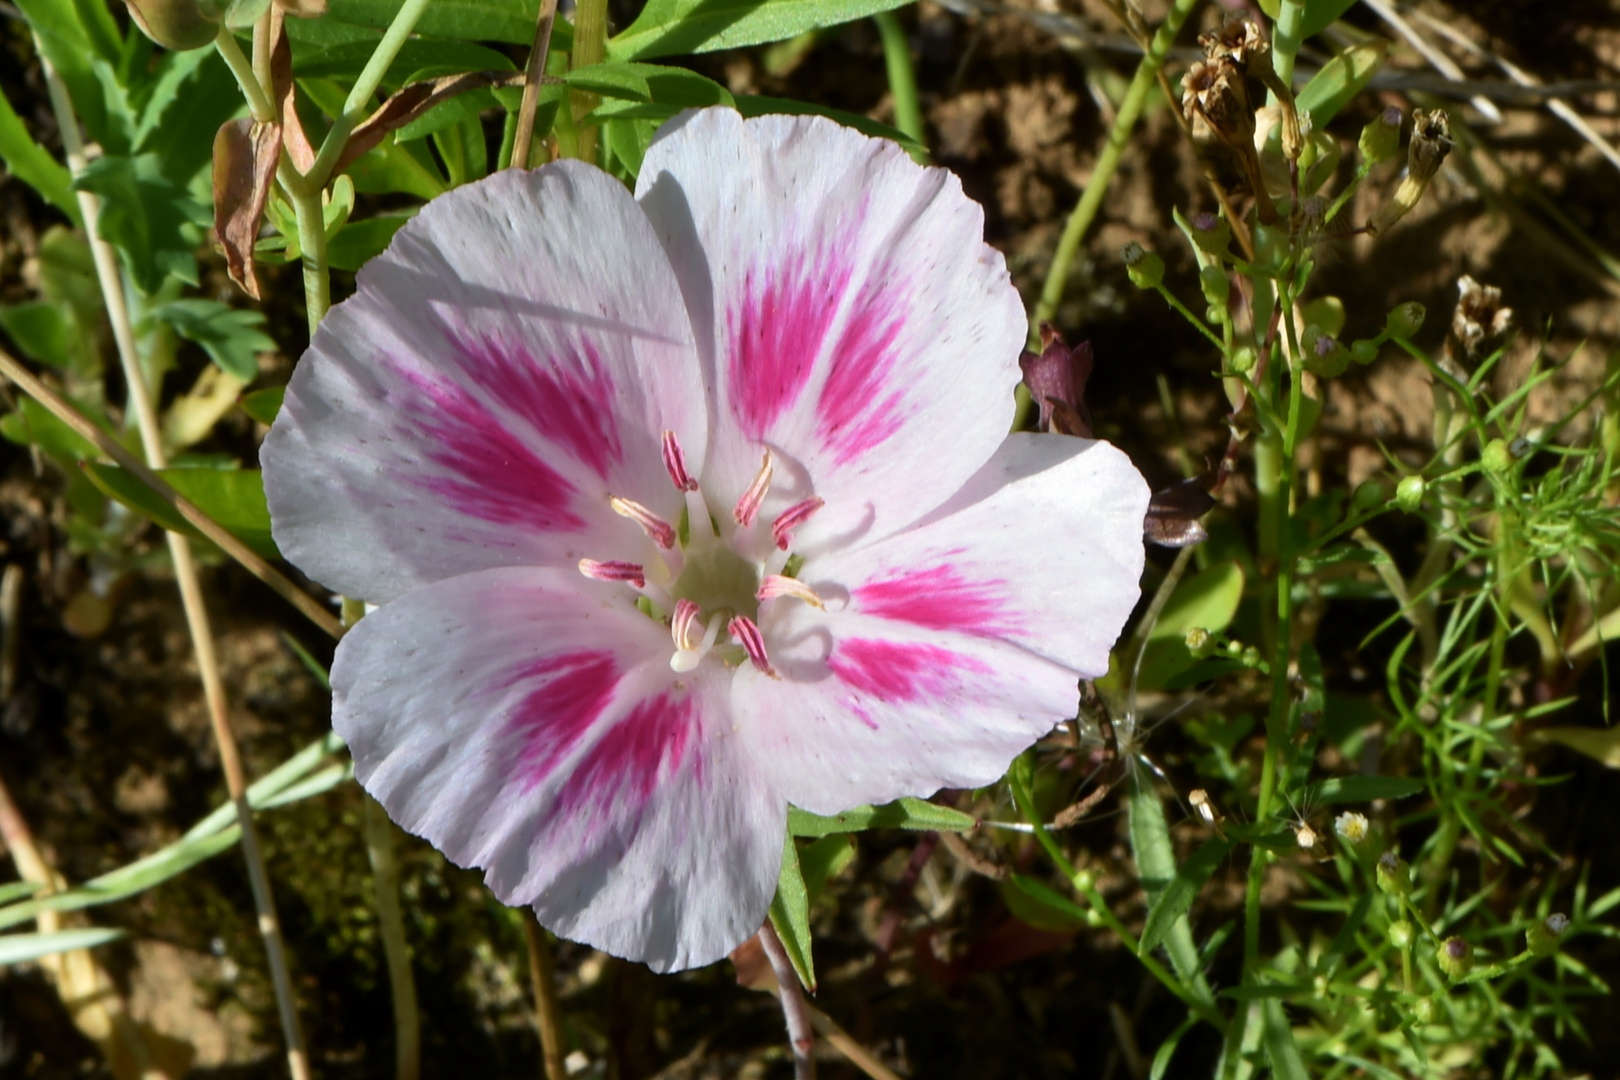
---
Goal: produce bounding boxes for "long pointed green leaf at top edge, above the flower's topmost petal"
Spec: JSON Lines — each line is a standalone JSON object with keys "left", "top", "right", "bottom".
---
{"left": 608, "top": 0, "right": 906, "bottom": 60}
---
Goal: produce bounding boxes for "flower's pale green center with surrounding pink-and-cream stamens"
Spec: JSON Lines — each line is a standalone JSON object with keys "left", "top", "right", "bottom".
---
{"left": 580, "top": 431, "right": 821, "bottom": 677}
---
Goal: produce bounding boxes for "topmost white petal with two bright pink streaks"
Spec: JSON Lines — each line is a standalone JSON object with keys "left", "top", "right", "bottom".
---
{"left": 637, "top": 108, "right": 1025, "bottom": 551}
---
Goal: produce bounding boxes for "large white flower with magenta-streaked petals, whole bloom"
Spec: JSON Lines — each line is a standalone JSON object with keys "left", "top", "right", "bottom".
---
{"left": 262, "top": 108, "right": 1149, "bottom": 970}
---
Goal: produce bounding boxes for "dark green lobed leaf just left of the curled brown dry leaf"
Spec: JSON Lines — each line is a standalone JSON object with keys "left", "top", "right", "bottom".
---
{"left": 73, "top": 154, "right": 214, "bottom": 296}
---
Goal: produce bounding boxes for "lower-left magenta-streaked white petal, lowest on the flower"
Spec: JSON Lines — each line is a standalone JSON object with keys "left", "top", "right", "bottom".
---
{"left": 332, "top": 568, "right": 786, "bottom": 970}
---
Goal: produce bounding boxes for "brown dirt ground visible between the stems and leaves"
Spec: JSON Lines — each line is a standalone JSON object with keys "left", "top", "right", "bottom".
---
{"left": 0, "top": 0, "right": 1620, "bottom": 1080}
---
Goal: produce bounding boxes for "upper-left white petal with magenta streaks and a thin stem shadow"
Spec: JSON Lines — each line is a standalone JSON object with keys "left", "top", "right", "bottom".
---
{"left": 261, "top": 162, "right": 706, "bottom": 601}
